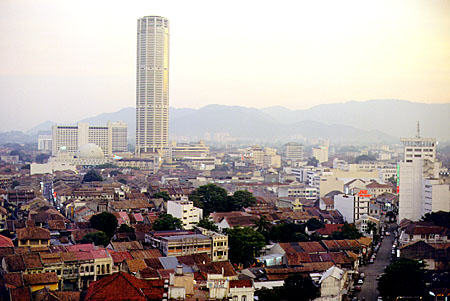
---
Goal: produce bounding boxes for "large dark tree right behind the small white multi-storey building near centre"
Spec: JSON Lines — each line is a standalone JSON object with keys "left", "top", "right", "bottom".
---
{"left": 189, "top": 184, "right": 230, "bottom": 216}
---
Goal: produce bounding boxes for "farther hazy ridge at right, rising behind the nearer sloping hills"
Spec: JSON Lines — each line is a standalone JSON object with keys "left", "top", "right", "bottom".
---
{"left": 262, "top": 99, "right": 450, "bottom": 140}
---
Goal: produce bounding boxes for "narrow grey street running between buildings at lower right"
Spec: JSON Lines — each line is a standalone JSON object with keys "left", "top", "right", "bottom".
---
{"left": 358, "top": 224, "right": 394, "bottom": 301}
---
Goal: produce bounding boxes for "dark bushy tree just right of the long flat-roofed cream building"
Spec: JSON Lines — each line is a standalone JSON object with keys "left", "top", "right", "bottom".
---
{"left": 225, "top": 227, "right": 266, "bottom": 266}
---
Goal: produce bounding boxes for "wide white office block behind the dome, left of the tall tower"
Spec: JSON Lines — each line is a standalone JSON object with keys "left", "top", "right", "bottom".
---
{"left": 52, "top": 122, "right": 128, "bottom": 157}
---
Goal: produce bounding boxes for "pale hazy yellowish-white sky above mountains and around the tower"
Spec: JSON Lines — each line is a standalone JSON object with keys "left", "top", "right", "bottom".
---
{"left": 0, "top": 0, "right": 450, "bottom": 131}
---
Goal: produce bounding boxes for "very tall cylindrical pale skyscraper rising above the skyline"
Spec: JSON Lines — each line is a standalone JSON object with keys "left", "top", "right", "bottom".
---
{"left": 136, "top": 16, "right": 169, "bottom": 155}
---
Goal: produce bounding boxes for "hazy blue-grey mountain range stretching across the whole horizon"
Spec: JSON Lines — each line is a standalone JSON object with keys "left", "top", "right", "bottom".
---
{"left": 8, "top": 100, "right": 450, "bottom": 144}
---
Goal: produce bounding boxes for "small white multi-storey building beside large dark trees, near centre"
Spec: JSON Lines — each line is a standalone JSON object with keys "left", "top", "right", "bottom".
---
{"left": 167, "top": 200, "right": 203, "bottom": 230}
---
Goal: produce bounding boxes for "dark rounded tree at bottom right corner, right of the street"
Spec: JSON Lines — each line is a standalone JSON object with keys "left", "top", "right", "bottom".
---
{"left": 378, "top": 258, "right": 426, "bottom": 301}
